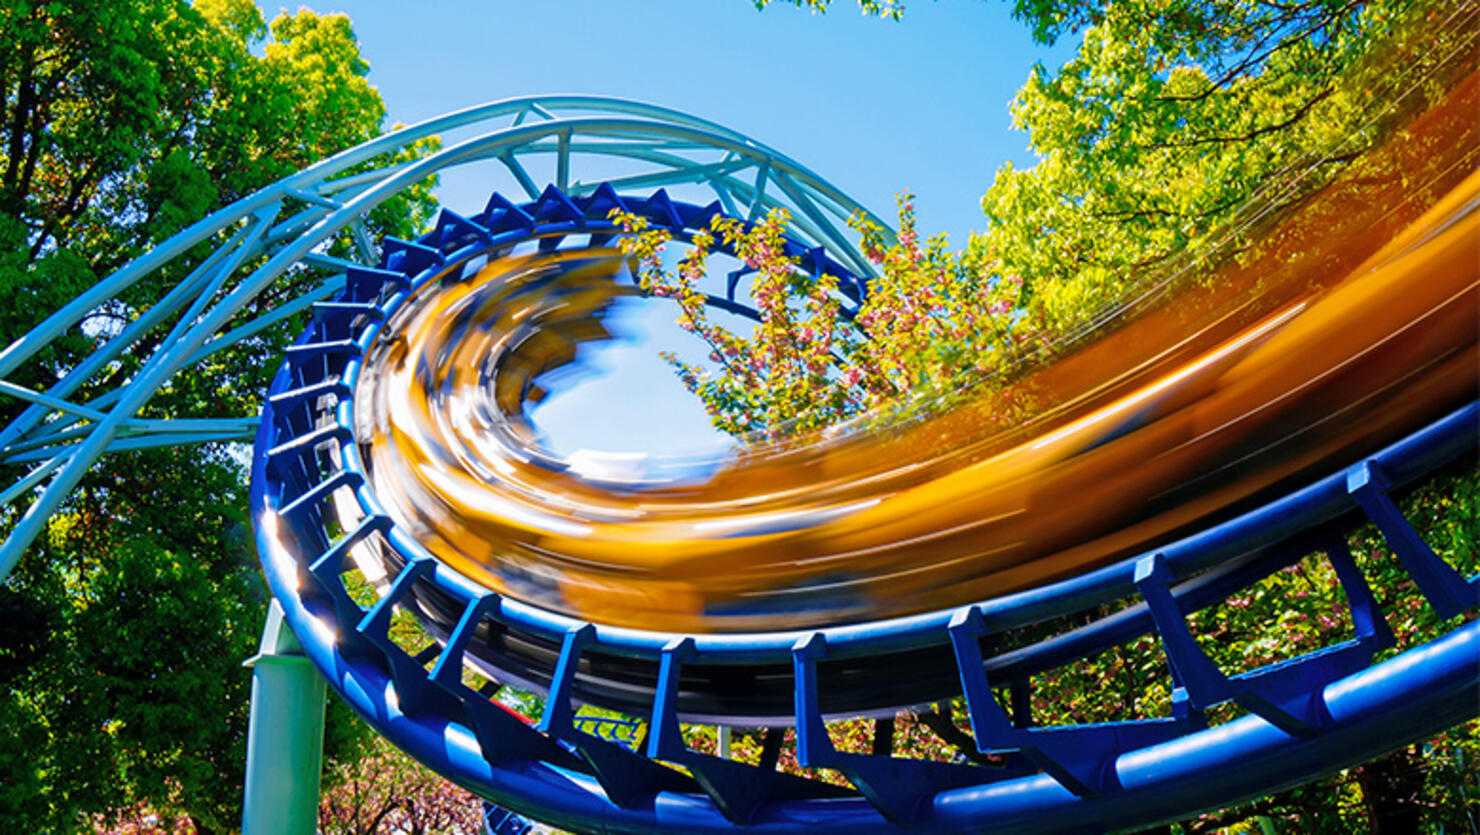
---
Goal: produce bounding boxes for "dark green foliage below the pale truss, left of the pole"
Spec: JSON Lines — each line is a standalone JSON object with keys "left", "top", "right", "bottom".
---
{"left": 0, "top": 450, "right": 265, "bottom": 832}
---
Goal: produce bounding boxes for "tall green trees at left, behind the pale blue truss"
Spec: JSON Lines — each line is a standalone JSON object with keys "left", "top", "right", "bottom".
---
{"left": 0, "top": 0, "right": 435, "bottom": 832}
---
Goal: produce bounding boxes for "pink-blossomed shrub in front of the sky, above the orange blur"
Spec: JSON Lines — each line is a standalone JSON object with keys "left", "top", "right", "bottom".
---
{"left": 613, "top": 194, "right": 1027, "bottom": 440}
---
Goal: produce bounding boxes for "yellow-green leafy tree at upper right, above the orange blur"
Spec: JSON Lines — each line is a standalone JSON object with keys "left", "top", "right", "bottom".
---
{"left": 972, "top": 0, "right": 1462, "bottom": 339}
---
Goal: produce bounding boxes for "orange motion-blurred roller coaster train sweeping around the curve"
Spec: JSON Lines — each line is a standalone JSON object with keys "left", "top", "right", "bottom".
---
{"left": 357, "top": 56, "right": 1480, "bottom": 631}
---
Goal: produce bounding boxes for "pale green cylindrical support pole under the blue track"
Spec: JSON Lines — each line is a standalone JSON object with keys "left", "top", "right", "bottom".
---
{"left": 241, "top": 601, "right": 324, "bottom": 835}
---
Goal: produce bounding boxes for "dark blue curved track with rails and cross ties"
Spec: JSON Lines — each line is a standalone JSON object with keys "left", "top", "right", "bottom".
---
{"left": 252, "top": 188, "right": 1480, "bottom": 834}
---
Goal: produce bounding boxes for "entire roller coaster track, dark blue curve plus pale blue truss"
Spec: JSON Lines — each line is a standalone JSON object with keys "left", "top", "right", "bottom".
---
{"left": 0, "top": 16, "right": 1480, "bottom": 832}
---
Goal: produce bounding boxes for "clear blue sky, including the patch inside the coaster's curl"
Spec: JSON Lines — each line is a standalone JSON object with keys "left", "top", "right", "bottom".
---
{"left": 303, "top": 0, "right": 1073, "bottom": 452}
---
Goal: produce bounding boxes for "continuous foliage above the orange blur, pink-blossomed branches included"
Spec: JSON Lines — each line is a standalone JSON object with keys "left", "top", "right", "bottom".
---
{"left": 677, "top": 0, "right": 1464, "bottom": 434}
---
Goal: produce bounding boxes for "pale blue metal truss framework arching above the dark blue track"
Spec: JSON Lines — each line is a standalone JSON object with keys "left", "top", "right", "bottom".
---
{"left": 0, "top": 96, "right": 884, "bottom": 582}
